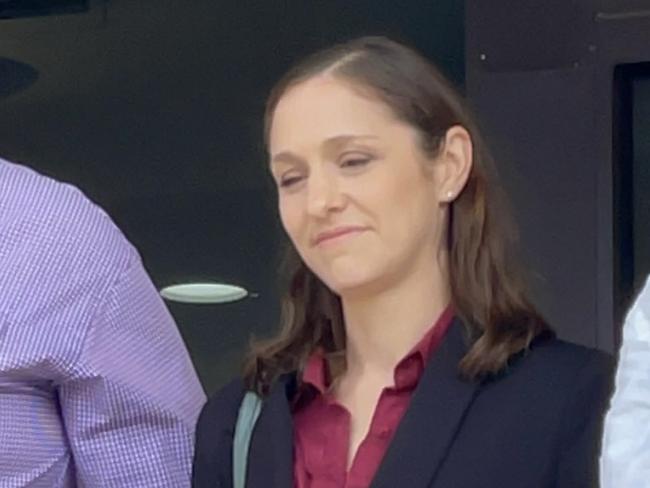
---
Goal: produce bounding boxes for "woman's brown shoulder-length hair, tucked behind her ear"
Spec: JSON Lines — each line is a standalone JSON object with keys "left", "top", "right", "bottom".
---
{"left": 244, "top": 37, "right": 550, "bottom": 394}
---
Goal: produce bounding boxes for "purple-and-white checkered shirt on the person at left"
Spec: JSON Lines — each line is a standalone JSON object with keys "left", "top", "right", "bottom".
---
{"left": 0, "top": 160, "right": 204, "bottom": 488}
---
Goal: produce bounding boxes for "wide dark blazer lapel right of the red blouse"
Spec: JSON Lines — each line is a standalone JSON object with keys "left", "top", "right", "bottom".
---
{"left": 371, "top": 319, "right": 478, "bottom": 488}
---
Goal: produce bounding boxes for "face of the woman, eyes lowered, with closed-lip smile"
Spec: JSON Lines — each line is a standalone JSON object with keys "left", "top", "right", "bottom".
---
{"left": 269, "top": 75, "right": 445, "bottom": 296}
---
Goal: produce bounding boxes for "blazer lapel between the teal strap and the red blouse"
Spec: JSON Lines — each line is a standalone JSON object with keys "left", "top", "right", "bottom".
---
{"left": 246, "top": 376, "right": 294, "bottom": 488}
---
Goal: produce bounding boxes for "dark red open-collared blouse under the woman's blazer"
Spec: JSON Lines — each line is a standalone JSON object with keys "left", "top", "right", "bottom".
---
{"left": 293, "top": 307, "right": 453, "bottom": 488}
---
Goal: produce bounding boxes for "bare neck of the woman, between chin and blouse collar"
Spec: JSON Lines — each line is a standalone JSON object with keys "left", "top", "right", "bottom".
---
{"left": 341, "top": 254, "right": 450, "bottom": 378}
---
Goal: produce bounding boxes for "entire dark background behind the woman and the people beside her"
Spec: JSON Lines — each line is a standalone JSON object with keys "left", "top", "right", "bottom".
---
{"left": 0, "top": 0, "right": 650, "bottom": 392}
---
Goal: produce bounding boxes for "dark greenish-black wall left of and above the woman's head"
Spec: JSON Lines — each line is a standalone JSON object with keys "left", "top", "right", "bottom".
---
{"left": 0, "top": 0, "right": 464, "bottom": 391}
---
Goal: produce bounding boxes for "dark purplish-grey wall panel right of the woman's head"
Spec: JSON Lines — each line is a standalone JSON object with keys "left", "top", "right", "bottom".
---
{"left": 466, "top": 0, "right": 650, "bottom": 351}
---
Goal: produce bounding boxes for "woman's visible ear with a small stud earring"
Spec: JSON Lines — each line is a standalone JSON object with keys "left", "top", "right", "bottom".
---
{"left": 437, "top": 125, "right": 473, "bottom": 203}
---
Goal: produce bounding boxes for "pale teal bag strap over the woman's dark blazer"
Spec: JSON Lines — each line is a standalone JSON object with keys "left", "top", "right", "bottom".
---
{"left": 232, "top": 391, "right": 262, "bottom": 488}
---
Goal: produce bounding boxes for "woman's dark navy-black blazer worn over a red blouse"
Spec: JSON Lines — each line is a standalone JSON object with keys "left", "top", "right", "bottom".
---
{"left": 193, "top": 320, "right": 612, "bottom": 488}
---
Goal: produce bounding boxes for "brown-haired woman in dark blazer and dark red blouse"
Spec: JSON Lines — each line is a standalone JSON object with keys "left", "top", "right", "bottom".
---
{"left": 193, "top": 38, "right": 609, "bottom": 488}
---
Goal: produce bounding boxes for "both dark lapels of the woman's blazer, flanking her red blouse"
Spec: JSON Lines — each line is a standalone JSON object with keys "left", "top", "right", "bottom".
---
{"left": 242, "top": 319, "right": 478, "bottom": 488}
